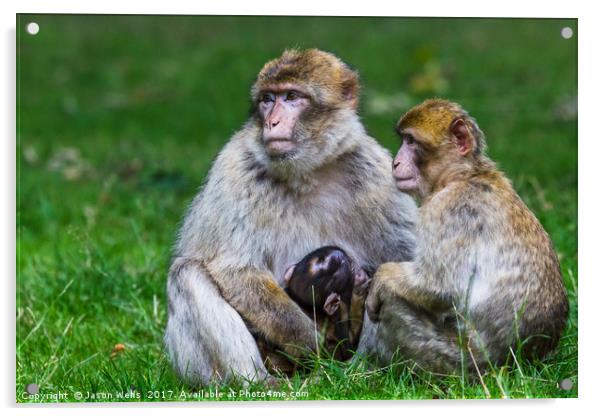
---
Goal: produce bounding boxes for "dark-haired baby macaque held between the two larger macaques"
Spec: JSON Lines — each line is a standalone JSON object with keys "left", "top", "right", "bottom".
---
{"left": 284, "top": 246, "right": 369, "bottom": 359}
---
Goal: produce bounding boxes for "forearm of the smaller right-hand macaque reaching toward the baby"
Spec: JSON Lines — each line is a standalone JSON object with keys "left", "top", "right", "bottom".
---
{"left": 366, "top": 262, "right": 449, "bottom": 321}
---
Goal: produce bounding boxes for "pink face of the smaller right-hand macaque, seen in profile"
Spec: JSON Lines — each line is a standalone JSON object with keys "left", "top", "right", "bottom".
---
{"left": 393, "top": 130, "right": 420, "bottom": 193}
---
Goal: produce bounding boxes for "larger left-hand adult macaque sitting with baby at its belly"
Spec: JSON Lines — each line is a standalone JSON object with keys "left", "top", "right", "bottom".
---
{"left": 165, "top": 49, "right": 416, "bottom": 384}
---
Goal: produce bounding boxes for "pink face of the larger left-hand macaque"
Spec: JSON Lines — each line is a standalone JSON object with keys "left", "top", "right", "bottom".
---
{"left": 254, "top": 84, "right": 310, "bottom": 156}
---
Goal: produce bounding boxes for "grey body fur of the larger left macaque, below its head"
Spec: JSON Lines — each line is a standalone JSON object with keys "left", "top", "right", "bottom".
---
{"left": 165, "top": 108, "right": 417, "bottom": 384}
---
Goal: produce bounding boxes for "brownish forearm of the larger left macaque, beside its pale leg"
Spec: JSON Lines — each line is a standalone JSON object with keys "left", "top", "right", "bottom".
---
{"left": 211, "top": 267, "right": 317, "bottom": 356}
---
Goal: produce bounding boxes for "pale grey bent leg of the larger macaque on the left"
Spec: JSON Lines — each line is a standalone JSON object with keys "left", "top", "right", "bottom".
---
{"left": 165, "top": 260, "right": 267, "bottom": 385}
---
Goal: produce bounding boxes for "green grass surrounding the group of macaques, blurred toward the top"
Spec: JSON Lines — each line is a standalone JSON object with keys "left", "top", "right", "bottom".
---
{"left": 16, "top": 15, "right": 578, "bottom": 402}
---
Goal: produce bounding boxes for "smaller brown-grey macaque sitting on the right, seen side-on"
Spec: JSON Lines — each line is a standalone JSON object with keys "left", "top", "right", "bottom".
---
{"left": 358, "top": 99, "right": 568, "bottom": 373}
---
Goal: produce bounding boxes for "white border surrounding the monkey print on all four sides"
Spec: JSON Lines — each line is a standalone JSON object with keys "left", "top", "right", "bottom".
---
{"left": 0, "top": 0, "right": 602, "bottom": 416}
